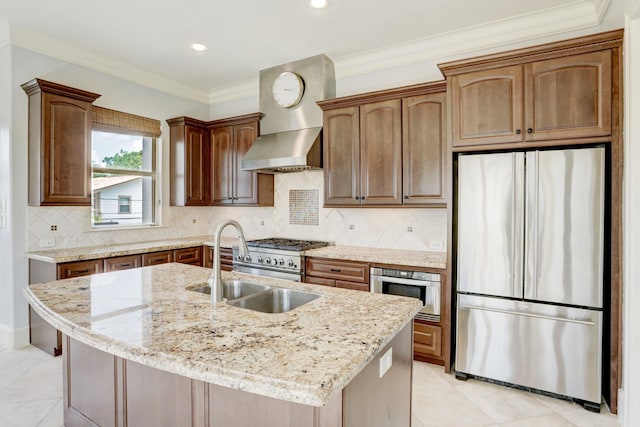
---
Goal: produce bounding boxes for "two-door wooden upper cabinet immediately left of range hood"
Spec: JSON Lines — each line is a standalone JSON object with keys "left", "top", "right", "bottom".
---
{"left": 209, "top": 114, "right": 273, "bottom": 206}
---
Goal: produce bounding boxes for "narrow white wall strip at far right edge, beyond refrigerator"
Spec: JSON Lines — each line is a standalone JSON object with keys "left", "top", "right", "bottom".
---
{"left": 620, "top": 0, "right": 640, "bottom": 427}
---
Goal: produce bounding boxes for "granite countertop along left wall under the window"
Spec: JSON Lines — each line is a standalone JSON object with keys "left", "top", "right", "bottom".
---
{"left": 25, "top": 235, "right": 238, "bottom": 264}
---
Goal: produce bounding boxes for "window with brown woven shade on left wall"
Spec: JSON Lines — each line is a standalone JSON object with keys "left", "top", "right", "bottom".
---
{"left": 91, "top": 106, "right": 160, "bottom": 227}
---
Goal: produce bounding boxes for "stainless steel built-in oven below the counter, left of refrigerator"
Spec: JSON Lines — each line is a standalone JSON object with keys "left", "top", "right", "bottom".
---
{"left": 370, "top": 267, "right": 441, "bottom": 322}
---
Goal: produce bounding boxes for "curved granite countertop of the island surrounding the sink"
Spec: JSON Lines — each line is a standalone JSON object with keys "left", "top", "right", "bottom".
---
{"left": 25, "top": 263, "right": 421, "bottom": 406}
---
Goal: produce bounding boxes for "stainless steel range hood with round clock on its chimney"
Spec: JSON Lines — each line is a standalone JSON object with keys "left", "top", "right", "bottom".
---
{"left": 240, "top": 54, "right": 336, "bottom": 173}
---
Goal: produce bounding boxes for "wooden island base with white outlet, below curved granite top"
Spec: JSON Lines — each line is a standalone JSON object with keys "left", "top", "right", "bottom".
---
{"left": 63, "top": 322, "right": 412, "bottom": 427}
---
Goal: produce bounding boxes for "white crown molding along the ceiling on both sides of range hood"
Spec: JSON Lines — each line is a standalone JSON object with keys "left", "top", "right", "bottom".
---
{"left": 6, "top": 0, "right": 612, "bottom": 106}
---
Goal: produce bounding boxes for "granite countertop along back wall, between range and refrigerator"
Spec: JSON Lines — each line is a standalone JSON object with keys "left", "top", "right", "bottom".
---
{"left": 304, "top": 245, "right": 447, "bottom": 269}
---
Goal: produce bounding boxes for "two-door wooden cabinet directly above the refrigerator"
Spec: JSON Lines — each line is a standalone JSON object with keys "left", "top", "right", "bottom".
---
{"left": 449, "top": 49, "right": 612, "bottom": 147}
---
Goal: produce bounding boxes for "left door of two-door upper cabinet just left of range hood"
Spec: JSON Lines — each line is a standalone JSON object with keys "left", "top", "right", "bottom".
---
{"left": 211, "top": 126, "right": 234, "bottom": 205}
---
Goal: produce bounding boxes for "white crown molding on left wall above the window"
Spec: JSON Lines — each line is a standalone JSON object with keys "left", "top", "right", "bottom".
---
{"left": 10, "top": 23, "right": 209, "bottom": 104}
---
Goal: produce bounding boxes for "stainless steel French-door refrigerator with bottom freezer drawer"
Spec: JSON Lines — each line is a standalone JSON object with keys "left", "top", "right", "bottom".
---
{"left": 455, "top": 147, "right": 605, "bottom": 410}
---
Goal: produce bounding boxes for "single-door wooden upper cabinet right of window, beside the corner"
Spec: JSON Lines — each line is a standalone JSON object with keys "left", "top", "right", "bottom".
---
{"left": 167, "top": 117, "right": 209, "bottom": 206}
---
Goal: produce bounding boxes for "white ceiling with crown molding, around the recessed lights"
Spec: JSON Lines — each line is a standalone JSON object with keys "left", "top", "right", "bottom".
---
{"left": 0, "top": 0, "right": 624, "bottom": 102}
